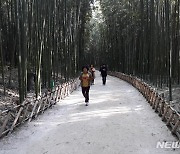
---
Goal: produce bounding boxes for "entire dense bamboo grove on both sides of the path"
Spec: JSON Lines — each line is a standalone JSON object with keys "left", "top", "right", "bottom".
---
{"left": 0, "top": 0, "right": 180, "bottom": 102}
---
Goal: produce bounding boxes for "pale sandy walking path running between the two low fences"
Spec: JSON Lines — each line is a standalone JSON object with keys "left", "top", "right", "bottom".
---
{"left": 0, "top": 74, "right": 180, "bottom": 154}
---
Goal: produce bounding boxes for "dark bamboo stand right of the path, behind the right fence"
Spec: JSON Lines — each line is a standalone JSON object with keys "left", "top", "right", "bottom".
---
{"left": 88, "top": 0, "right": 180, "bottom": 100}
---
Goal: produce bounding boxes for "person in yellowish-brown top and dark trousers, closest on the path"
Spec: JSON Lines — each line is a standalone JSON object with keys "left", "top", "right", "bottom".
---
{"left": 79, "top": 66, "right": 93, "bottom": 106}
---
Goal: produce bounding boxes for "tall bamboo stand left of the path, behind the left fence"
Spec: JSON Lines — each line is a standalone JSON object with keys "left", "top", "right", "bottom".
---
{"left": 0, "top": 0, "right": 91, "bottom": 102}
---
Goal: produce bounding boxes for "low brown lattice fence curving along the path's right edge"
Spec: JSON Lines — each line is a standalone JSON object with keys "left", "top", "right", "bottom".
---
{"left": 109, "top": 72, "right": 180, "bottom": 140}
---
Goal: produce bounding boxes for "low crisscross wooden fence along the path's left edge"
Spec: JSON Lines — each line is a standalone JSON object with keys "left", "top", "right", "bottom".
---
{"left": 0, "top": 79, "right": 79, "bottom": 138}
